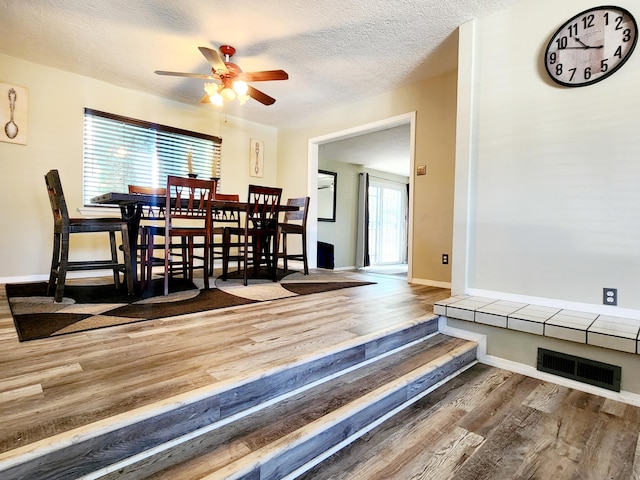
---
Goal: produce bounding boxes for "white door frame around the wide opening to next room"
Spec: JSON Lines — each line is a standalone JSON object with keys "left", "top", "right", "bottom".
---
{"left": 307, "top": 111, "right": 416, "bottom": 283}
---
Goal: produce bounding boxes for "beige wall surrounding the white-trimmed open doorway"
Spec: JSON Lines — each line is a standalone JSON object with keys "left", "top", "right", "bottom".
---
{"left": 278, "top": 72, "right": 457, "bottom": 284}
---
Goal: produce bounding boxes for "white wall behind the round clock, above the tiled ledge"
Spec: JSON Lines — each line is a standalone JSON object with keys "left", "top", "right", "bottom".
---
{"left": 453, "top": 0, "right": 640, "bottom": 315}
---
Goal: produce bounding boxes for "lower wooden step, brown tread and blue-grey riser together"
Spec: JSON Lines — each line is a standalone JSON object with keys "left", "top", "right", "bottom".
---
{"left": 101, "top": 334, "right": 476, "bottom": 479}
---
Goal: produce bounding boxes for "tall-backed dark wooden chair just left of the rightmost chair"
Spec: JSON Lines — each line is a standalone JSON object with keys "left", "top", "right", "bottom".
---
{"left": 222, "top": 185, "right": 282, "bottom": 286}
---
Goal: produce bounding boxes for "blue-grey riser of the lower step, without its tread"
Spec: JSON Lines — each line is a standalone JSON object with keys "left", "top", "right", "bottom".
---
{"left": 220, "top": 347, "right": 476, "bottom": 480}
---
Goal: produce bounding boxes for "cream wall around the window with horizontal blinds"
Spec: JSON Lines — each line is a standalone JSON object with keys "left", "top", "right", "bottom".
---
{"left": 0, "top": 51, "right": 277, "bottom": 282}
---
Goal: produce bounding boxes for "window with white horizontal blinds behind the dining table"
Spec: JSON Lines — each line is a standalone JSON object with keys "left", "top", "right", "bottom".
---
{"left": 83, "top": 108, "right": 222, "bottom": 206}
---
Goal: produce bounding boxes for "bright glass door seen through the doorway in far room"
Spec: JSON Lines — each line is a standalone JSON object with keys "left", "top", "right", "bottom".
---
{"left": 369, "top": 177, "right": 408, "bottom": 265}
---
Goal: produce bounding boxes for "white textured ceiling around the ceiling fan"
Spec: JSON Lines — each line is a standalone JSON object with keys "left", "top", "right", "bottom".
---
{"left": 0, "top": 0, "right": 517, "bottom": 127}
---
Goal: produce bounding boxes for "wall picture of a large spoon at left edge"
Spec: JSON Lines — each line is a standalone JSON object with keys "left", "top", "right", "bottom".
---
{"left": 0, "top": 83, "right": 28, "bottom": 145}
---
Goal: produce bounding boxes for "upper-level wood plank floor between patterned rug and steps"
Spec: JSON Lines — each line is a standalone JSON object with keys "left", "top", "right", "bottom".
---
{"left": 0, "top": 268, "right": 449, "bottom": 461}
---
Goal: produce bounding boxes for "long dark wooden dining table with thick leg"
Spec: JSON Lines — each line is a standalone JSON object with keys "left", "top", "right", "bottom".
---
{"left": 91, "top": 192, "right": 298, "bottom": 290}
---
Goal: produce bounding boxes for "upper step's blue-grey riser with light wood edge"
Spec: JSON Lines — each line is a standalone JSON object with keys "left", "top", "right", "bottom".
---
{"left": 0, "top": 316, "right": 450, "bottom": 479}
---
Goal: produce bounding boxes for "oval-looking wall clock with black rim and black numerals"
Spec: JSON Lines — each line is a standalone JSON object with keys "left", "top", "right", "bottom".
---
{"left": 544, "top": 6, "right": 638, "bottom": 87}
